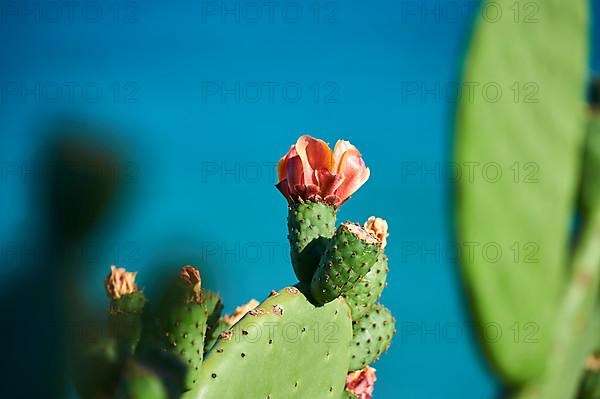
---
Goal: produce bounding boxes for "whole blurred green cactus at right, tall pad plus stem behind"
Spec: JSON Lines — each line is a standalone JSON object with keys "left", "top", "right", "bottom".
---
{"left": 455, "top": 0, "right": 600, "bottom": 399}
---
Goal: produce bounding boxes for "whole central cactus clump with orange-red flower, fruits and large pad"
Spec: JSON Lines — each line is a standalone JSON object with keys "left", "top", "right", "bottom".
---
{"left": 78, "top": 136, "right": 395, "bottom": 399}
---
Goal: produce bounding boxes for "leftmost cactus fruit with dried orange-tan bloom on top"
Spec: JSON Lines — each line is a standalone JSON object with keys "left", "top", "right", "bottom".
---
{"left": 105, "top": 266, "right": 146, "bottom": 354}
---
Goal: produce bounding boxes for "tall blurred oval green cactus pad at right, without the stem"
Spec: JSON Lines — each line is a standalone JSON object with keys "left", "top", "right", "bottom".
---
{"left": 455, "top": 0, "right": 590, "bottom": 384}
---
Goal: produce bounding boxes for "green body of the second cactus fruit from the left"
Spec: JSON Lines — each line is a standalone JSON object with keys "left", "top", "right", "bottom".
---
{"left": 156, "top": 268, "right": 208, "bottom": 389}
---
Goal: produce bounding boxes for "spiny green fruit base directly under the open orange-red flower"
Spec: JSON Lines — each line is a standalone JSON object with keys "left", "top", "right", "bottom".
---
{"left": 288, "top": 202, "right": 335, "bottom": 282}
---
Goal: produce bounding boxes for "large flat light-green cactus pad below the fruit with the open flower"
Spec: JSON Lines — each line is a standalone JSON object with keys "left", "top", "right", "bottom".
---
{"left": 184, "top": 287, "right": 352, "bottom": 399}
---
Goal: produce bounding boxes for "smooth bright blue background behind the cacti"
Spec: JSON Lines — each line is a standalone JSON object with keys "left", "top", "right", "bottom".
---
{"left": 0, "top": 1, "right": 600, "bottom": 399}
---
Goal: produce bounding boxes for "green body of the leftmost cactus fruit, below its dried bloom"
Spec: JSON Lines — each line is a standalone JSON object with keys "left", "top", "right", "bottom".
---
{"left": 108, "top": 291, "right": 147, "bottom": 354}
